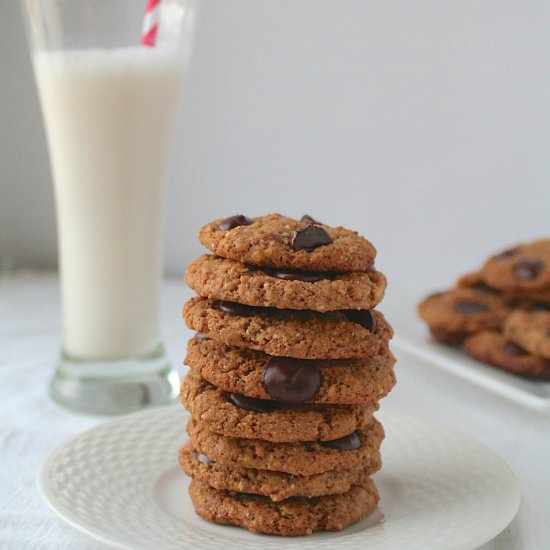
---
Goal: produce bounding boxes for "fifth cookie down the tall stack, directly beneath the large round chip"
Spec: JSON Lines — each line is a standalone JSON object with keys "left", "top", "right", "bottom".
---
{"left": 181, "top": 371, "right": 377, "bottom": 442}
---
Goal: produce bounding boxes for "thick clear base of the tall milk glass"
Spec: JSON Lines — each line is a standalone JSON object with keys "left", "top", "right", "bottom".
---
{"left": 50, "top": 345, "right": 181, "bottom": 415}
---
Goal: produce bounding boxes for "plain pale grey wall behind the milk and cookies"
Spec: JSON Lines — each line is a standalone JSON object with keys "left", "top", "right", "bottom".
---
{"left": 0, "top": 0, "right": 550, "bottom": 298}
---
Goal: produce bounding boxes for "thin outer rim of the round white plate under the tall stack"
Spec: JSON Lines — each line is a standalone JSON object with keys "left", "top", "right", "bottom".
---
{"left": 36, "top": 405, "right": 522, "bottom": 550}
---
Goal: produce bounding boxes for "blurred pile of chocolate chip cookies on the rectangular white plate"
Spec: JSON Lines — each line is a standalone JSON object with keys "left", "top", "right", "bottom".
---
{"left": 418, "top": 239, "right": 550, "bottom": 380}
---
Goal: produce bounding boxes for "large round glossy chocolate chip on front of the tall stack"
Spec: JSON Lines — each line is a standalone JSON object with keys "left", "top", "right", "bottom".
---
{"left": 263, "top": 357, "right": 321, "bottom": 403}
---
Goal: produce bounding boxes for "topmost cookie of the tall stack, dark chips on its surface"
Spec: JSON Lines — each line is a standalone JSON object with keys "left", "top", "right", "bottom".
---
{"left": 199, "top": 214, "right": 376, "bottom": 272}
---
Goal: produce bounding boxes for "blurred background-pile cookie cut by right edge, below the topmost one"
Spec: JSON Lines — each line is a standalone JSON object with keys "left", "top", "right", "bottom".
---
{"left": 504, "top": 309, "right": 550, "bottom": 359}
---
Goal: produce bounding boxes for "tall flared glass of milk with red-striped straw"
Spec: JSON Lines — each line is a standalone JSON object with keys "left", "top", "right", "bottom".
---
{"left": 22, "top": 0, "right": 195, "bottom": 414}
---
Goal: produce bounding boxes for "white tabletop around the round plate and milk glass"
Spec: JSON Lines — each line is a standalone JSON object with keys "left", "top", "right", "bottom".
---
{"left": 0, "top": 273, "right": 550, "bottom": 550}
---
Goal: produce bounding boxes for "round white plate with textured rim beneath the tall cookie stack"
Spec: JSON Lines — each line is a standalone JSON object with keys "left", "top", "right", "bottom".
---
{"left": 38, "top": 406, "right": 520, "bottom": 550}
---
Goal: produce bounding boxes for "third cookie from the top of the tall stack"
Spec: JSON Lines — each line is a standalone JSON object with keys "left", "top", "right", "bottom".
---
{"left": 184, "top": 297, "right": 392, "bottom": 359}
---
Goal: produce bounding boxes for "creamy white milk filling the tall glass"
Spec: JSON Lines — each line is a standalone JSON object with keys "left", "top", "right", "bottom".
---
{"left": 34, "top": 48, "right": 183, "bottom": 359}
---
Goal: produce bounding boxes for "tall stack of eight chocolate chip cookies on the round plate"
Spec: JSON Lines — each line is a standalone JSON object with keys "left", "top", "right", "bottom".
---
{"left": 180, "top": 214, "right": 395, "bottom": 536}
